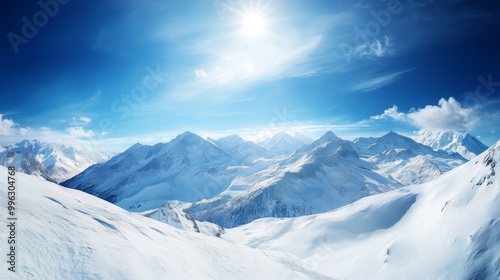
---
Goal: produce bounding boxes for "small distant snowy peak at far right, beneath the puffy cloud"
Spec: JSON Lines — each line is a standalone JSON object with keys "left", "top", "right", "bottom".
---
{"left": 415, "top": 130, "right": 488, "bottom": 159}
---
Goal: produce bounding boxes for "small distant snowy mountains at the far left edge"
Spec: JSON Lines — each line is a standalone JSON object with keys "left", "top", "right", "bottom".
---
{"left": 0, "top": 140, "right": 111, "bottom": 182}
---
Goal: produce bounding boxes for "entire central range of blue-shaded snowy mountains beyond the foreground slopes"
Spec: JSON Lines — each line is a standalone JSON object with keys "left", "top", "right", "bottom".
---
{"left": 62, "top": 129, "right": 484, "bottom": 227}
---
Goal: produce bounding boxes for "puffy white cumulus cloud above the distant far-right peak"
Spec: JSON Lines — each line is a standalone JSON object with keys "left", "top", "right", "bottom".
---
{"left": 365, "top": 97, "right": 479, "bottom": 130}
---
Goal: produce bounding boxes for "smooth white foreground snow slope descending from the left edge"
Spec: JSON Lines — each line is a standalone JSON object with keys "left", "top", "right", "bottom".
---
{"left": 0, "top": 167, "right": 322, "bottom": 280}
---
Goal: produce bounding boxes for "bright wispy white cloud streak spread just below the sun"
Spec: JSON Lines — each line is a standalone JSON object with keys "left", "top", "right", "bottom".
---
{"left": 175, "top": 35, "right": 321, "bottom": 100}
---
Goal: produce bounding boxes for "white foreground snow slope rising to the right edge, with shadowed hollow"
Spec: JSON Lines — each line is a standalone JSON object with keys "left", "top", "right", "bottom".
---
{"left": 228, "top": 141, "right": 500, "bottom": 280}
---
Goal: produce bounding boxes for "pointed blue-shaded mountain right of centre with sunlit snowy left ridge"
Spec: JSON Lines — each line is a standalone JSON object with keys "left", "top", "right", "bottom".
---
{"left": 185, "top": 132, "right": 400, "bottom": 227}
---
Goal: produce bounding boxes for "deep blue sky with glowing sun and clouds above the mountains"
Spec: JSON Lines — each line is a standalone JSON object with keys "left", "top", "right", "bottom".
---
{"left": 0, "top": 0, "right": 500, "bottom": 151}
